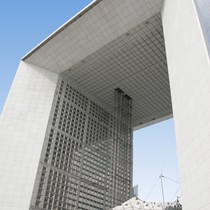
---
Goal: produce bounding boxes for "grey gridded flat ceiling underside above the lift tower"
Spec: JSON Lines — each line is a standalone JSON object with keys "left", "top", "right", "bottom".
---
{"left": 63, "top": 13, "right": 172, "bottom": 126}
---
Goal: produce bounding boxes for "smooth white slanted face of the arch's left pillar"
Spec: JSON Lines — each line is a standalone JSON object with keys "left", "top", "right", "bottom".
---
{"left": 0, "top": 62, "right": 58, "bottom": 210}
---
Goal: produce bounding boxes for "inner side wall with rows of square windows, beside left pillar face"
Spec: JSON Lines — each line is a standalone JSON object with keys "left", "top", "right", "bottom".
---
{"left": 30, "top": 78, "right": 131, "bottom": 210}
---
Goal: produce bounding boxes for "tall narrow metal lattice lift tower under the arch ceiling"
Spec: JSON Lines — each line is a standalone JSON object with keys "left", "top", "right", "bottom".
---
{"left": 112, "top": 88, "right": 132, "bottom": 206}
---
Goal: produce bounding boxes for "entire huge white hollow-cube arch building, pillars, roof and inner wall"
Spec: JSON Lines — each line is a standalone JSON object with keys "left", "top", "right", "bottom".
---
{"left": 0, "top": 0, "right": 210, "bottom": 210}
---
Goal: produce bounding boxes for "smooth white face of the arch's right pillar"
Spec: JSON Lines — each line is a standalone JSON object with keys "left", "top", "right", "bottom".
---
{"left": 162, "top": 0, "right": 210, "bottom": 210}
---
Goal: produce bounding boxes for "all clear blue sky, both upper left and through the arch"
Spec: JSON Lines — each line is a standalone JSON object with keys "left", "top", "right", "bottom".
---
{"left": 0, "top": 0, "right": 180, "bottom": 201}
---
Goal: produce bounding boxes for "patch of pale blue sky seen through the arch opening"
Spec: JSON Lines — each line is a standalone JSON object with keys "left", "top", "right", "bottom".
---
{"left": 133, "top": 119, "right": 180, "bottom": 201}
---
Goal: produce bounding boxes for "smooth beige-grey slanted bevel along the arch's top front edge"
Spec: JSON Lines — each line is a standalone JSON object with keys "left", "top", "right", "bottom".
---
{"left": 23, "top": 0, "right": 162, "bottom": 73}
